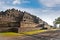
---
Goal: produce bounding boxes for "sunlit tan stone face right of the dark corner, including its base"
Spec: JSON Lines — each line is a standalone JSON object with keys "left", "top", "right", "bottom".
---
{"left": 18, "top": 12, "right": 41, "bottom": 32}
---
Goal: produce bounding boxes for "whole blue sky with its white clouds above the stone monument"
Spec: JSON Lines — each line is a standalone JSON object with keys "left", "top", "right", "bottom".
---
{"left": 0, "top": 0, "right": 60, "bottom": 25}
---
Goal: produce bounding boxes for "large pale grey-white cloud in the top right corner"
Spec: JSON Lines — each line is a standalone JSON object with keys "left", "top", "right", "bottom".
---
{"left": 39, "top": 0, "right": 60, "bottom": 7}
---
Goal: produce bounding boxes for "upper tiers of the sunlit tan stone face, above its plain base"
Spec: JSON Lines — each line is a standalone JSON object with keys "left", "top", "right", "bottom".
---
{"left": 20, "top": 12, "right": 38, "bottom": 27}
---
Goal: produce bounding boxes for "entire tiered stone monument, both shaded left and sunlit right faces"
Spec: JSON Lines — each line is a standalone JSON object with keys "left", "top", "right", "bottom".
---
{"left": 0, "top": 8, "right": 50, "bottom": 32}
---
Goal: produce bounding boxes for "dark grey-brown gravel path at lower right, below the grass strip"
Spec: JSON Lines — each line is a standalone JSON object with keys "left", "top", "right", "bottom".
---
{"left": 20, "top": 30, "right": 60, "bottom": 40}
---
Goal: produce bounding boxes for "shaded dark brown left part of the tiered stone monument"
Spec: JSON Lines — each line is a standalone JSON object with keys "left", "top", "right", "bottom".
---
{"left": 0, "top": 9, "right": 23, "bottom": 32}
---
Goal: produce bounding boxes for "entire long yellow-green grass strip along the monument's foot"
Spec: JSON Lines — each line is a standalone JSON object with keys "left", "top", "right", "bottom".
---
{"left": 0, "top": 29, "right": 56, "bottom": 37}
